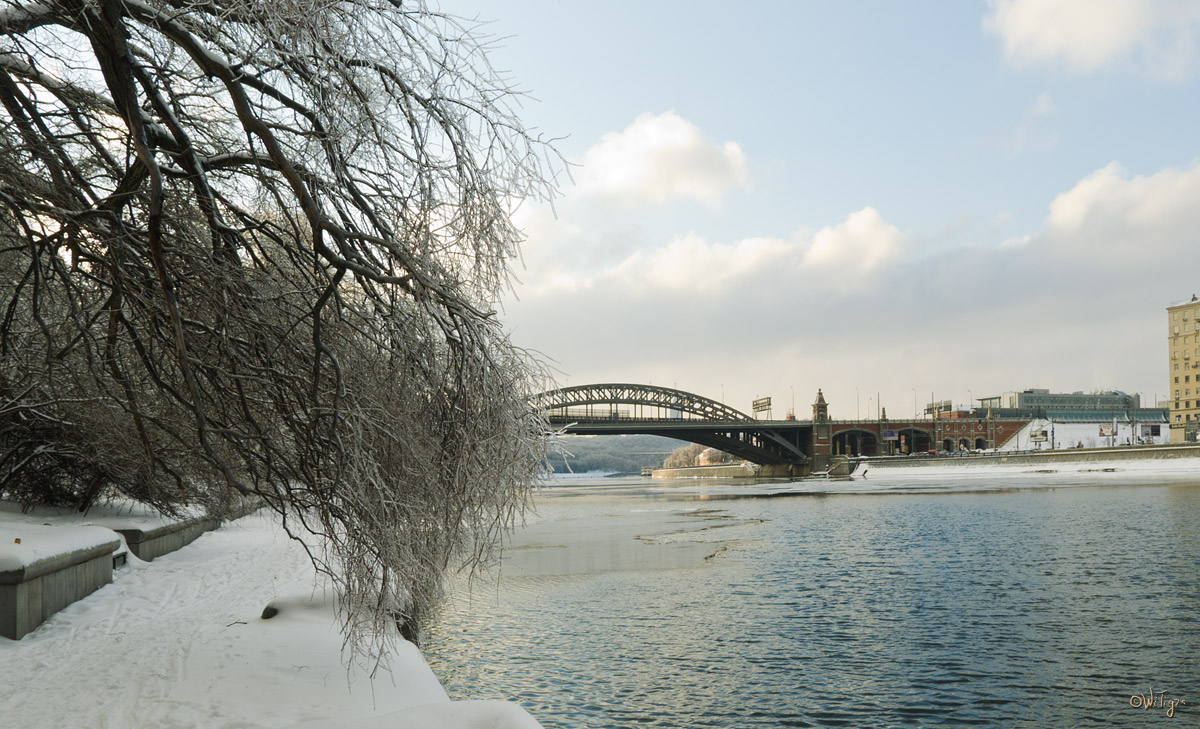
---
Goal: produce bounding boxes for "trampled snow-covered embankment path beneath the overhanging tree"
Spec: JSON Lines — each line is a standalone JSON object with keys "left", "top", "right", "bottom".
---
{"left": 0, "top": 513, "right": 539, "bottom": 729}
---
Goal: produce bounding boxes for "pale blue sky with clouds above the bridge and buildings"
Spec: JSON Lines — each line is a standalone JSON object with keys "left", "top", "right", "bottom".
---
{"left": 442, "top": 0, "right": 1200, "bottom": 418}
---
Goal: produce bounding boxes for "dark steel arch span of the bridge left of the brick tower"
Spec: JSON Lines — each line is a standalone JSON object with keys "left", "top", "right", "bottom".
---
{"left": 532, "top": 382, "right": 812, "bottom": 465}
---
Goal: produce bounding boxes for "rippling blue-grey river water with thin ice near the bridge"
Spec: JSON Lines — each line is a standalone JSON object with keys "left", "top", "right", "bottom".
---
{"left": 424, "top": 469, "right": 1200, "bottom": 729}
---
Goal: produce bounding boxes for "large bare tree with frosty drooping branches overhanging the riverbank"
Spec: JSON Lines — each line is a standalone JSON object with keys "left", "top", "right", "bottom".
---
{"left": 0, "top": 0, "right": 557, "bottom": 641}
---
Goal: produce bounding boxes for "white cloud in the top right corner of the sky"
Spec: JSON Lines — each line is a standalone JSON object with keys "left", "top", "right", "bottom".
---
{"left": 983, "top": 0, "right": 1200, "bottom": 78}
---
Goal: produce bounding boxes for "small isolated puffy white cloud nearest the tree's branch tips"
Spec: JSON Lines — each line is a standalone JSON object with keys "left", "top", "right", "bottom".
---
{"left": 572, "top": 112, "right": 748, "bottom": 206}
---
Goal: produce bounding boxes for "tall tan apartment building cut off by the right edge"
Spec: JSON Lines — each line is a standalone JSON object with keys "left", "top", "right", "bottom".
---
{"left": 1166, "top": 294, "right": 1200, "bottom": 442}
